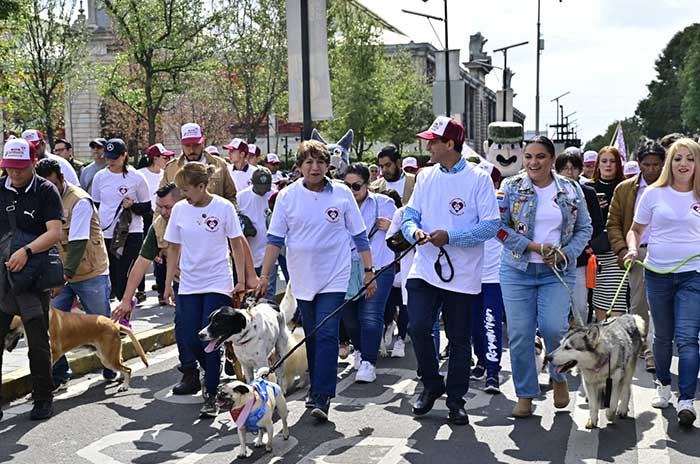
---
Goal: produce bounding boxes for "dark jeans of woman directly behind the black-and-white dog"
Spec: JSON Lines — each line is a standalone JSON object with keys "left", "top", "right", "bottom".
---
{"left": 175, "top": 293, "right": 231, "bottom": 395}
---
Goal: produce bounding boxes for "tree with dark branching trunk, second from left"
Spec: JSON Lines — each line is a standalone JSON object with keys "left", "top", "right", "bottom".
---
{"left": 102, "top": 0, "right": 224, "bottom": 144}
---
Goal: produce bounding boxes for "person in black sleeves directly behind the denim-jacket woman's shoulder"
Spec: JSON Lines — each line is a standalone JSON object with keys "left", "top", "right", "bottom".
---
{"left": 554, "top": 152, "right": 605, "bottom": 324}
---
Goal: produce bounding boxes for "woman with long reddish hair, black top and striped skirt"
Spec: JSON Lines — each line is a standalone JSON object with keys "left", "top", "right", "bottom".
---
{"left": 589, "top": 146, "right": 627, "bottom": 321}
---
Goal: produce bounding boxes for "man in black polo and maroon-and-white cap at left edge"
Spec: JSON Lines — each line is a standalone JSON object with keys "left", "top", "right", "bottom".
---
{"left": 0, "top": 138, "right": 64, "bottom": 420}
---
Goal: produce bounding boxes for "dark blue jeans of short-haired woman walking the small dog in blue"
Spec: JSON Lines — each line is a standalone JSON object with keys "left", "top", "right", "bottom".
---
{"left": 297, "top": 292, "right": 345, "bottom": 398}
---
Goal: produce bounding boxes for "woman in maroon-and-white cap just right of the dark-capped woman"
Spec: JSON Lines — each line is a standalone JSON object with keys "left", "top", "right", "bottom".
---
{"left": 136, "top": 143, "right": 175, "bottom": 304}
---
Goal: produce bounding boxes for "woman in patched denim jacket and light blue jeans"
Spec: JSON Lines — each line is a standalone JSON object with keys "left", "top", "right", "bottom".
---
{"left": 496, "top": 136, "right": 593, "bottom": 417}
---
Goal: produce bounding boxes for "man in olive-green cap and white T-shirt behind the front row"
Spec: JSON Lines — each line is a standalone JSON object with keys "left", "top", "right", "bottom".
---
{"left": 236, "top": 167, "right": 277, "bottom": 301}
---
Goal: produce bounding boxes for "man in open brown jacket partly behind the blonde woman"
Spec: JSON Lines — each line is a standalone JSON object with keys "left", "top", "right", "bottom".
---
{"left": 607, "top": 143, "right": 666, "bottom": 372}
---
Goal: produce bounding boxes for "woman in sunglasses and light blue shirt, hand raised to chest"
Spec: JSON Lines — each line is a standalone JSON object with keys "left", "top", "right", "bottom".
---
{"left": 343, "top": 163, "right": 396, "bottom": 383}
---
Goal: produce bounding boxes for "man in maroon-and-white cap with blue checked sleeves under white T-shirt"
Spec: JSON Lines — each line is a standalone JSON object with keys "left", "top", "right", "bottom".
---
{"left": 401, "top": 116, "right": 500, "bottom": 425}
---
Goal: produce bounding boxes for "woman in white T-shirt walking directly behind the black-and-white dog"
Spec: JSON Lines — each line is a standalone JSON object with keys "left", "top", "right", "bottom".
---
{"left": 163, "top": 162, "right": 250, "bottom": 417}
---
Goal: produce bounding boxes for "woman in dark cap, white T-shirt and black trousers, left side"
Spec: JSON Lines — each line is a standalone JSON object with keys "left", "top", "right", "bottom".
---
{"left": 92, "top": 139, "right": 151, "bottom": 300}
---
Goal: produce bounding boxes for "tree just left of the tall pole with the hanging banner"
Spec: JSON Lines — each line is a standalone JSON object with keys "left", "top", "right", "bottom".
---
{"left": 215, "top": 0, "right": 287, "bottom": 142}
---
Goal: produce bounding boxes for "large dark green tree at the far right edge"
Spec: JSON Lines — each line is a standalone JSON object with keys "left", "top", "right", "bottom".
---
{"left": 635, "top": 23, "right": 700, "bottom": 138}
